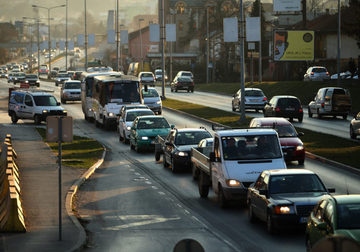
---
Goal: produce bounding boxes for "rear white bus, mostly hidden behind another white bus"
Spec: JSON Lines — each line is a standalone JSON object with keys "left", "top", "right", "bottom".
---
{"left": 80, "top": 71, "right": 119, "bottom": 122}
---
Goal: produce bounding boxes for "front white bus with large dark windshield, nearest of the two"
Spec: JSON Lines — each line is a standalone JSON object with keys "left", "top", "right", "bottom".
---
{"left": 92, "top": 75, "right": 144, "bottom": 130}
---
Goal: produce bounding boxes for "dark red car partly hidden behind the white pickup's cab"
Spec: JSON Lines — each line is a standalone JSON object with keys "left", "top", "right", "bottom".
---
{"left": 249, "top": 117, "right": 305, "bottom": 165}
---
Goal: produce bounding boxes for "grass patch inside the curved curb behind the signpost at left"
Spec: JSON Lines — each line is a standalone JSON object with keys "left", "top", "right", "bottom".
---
{"left": 36, "top": 128, "right": 103, "bottom": 168}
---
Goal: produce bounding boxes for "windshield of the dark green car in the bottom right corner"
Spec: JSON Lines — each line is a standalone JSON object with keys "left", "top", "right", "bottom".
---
{"left": 337, "top": 203, "right": 360, "bottom": 229}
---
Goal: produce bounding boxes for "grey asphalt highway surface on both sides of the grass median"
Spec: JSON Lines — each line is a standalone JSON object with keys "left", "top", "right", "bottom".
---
{"left": 0, "top": 74, "right": 360, "bottom": 252}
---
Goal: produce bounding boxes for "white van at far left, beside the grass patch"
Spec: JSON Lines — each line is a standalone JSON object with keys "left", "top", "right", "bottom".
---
{"left": 8, "top": 90, "right": 67, "bottom": 124}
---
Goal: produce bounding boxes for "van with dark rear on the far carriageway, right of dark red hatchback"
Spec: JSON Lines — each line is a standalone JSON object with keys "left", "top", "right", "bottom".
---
{"left": 308, "top": 87, "right": 351, "bottom": 120}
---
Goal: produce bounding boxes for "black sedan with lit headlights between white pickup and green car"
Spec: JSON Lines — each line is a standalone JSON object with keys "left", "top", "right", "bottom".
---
{"left": 247, "top": 169, "right": 335, "bottom": 235}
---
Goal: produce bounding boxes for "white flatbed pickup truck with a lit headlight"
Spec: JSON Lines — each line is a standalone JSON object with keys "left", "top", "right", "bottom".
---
{"left": 190, "top": 128, "right": 287, "bottom": 208}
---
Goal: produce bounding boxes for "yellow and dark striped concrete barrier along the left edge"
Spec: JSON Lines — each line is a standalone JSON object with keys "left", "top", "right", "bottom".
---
{"left": 0, "top": 135, "right": 26, "bottom": 232}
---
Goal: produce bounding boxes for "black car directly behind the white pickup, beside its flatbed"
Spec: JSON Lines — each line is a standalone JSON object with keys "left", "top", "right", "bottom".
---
{"left": 163, "top": 127, "right": 212, "bottom": 173}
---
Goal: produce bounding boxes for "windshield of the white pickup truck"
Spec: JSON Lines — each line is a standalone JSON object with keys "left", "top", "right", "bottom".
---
{"left": 221, "top": 135, "right": 282, "bottom": 160}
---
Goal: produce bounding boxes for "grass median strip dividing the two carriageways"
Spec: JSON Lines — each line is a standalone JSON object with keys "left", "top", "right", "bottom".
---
{"left": 163, "top": 98, "right": 360, "bottom": 168}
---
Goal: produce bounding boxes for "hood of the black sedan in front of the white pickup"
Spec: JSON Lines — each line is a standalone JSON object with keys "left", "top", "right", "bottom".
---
{"left": 270, "top": 192, "right": 328, "bottom": 205}
